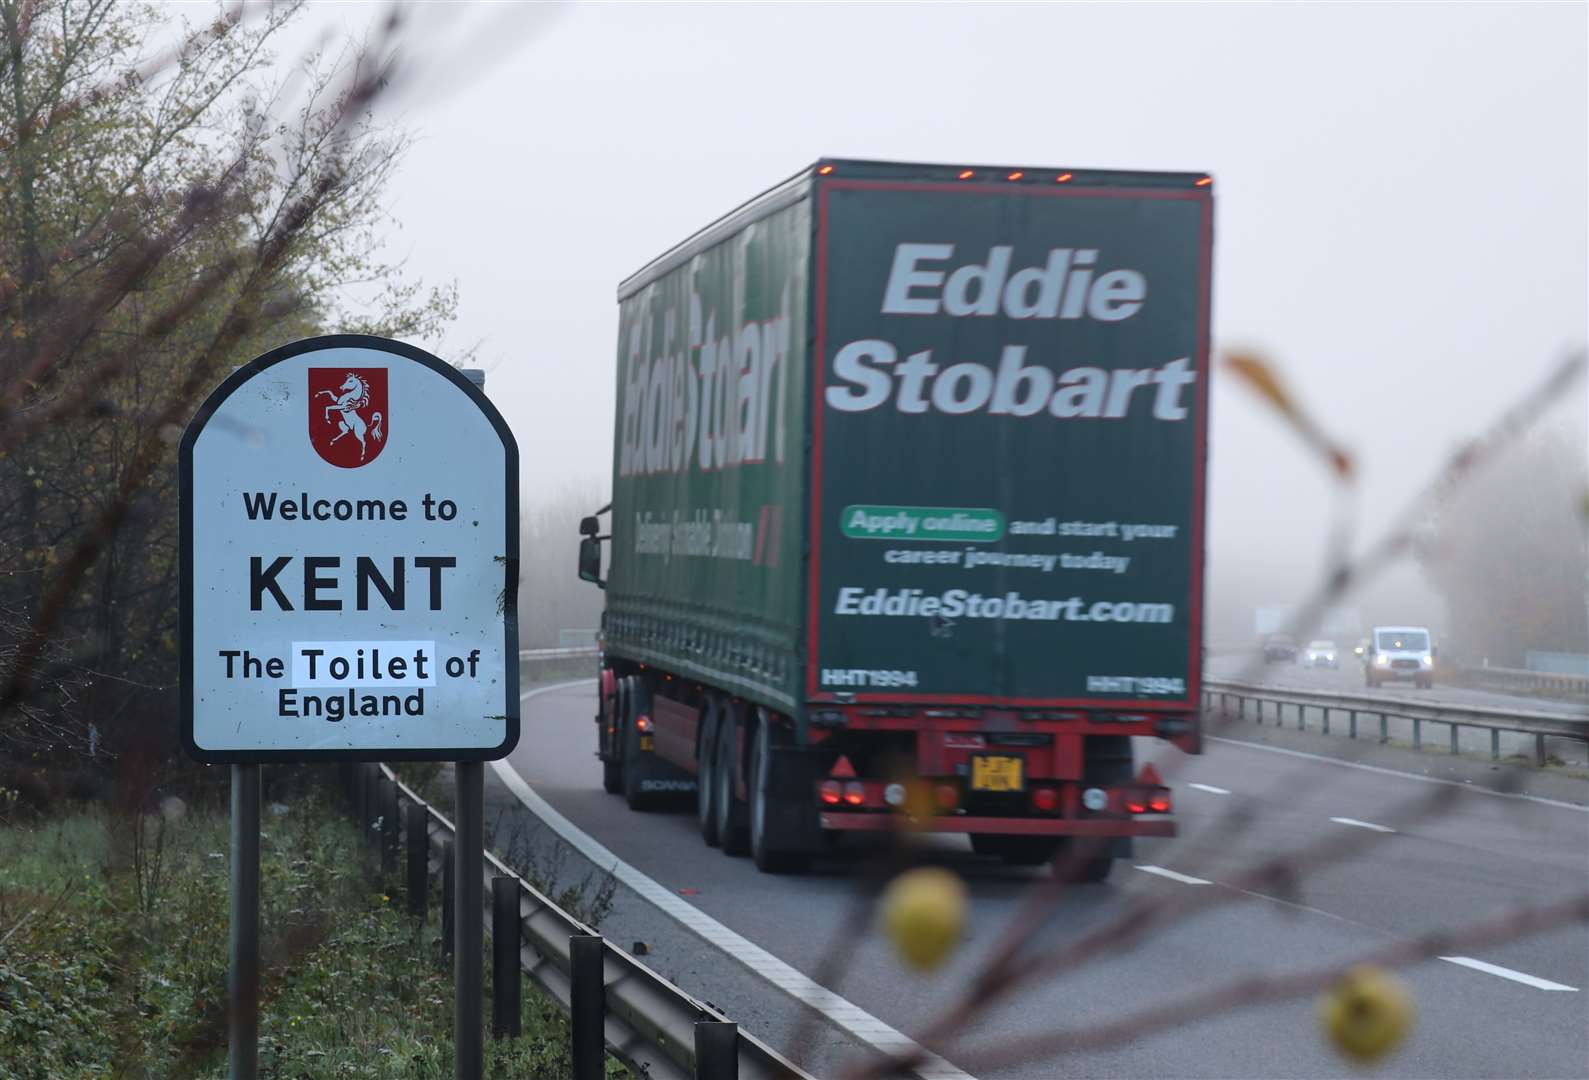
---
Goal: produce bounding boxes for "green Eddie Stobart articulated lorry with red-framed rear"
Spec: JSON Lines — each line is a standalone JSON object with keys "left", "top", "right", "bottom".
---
{"left": 580, "top": 159, "right": 1212, "bottom": 880}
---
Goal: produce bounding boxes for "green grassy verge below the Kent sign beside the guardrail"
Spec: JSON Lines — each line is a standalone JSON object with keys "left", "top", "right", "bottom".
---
{"left": 0, "top": 787, "right": 628, "bottom": 1080}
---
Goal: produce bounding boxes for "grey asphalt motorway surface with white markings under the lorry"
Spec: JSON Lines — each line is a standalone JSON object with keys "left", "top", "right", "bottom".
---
{"left": 488, "top": 673, "right": 1589, "bottom": 1078}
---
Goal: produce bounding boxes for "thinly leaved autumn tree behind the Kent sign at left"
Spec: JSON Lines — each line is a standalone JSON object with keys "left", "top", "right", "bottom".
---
{"left": 0, "top": 0, "right": 456, "bottom": 775}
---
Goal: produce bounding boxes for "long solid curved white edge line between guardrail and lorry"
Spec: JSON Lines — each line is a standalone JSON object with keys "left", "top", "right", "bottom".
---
{"left": 491, "top": 678, "right": 976, "bottom": 1080}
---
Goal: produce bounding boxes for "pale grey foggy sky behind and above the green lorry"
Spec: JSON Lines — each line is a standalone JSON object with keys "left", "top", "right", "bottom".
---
{"left": 270, "top": 3, "right": 1589, "bottom": 635}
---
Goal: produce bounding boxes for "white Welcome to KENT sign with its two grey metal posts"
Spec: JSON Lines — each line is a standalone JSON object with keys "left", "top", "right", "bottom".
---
{"left": 180, "top": 335, "right": 518, "bottom": 1080}
